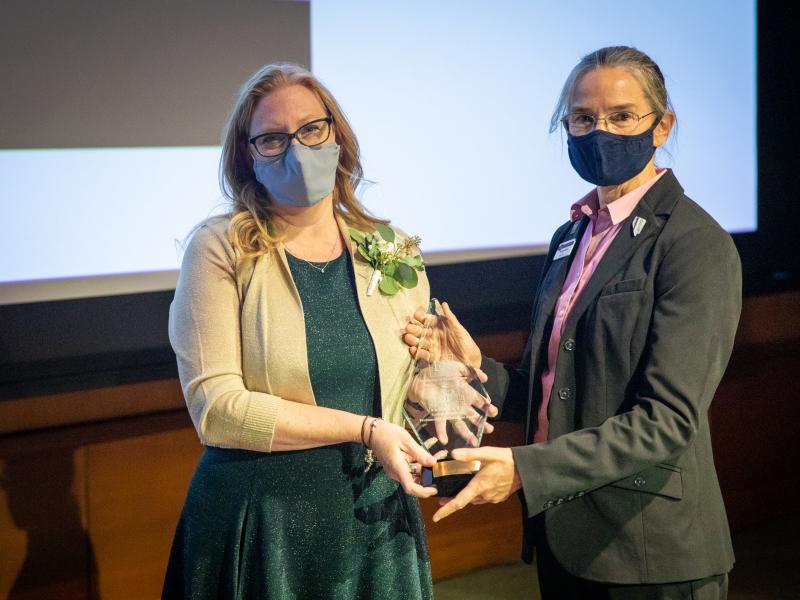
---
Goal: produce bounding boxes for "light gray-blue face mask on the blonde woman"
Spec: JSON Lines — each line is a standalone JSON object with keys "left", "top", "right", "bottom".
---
{"left": 253, "top": 144, "right": 339, "bottom": 208}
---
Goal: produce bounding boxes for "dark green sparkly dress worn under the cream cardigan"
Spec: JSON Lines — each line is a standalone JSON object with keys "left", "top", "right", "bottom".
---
{"left": 163, "top": 253, "right": 433, "bottom": 600}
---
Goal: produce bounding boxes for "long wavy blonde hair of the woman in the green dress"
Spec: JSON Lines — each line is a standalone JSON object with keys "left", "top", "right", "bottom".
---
{"left": 220, "top": 63, "right": 386, "bottom": 260}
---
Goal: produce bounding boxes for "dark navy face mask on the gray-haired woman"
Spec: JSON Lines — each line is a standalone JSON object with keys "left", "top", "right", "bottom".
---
{"left": 567, "top": 123, "right": 658, "bottom": 185}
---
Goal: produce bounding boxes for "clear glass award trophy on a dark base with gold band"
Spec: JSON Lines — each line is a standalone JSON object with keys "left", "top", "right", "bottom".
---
{"left": 403, "top": 298, "right": 491, "bottom": 497}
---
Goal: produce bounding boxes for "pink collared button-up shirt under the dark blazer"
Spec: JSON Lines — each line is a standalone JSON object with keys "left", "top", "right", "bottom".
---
{"left": 533, "top": 169, "right": 667, "bottom": 442}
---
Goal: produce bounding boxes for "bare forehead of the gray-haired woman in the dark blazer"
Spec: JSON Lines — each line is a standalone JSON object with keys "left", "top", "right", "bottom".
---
{"left": 569, "top": 67, "right": 650, "bottom": 108}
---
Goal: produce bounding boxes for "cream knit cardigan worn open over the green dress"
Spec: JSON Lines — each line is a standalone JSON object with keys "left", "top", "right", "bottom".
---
{"left": 169, "top": 217, "right": 430, "bottom": 452}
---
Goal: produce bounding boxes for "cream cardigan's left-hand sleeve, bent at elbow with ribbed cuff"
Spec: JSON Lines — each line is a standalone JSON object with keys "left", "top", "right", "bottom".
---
{"left": 169, "top": 219, "right": 280, "bottom": 452}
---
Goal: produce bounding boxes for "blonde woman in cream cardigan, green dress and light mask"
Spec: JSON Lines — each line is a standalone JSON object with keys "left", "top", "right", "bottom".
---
{"left": 163, "top": 65, "right": 435, "bottom": 599}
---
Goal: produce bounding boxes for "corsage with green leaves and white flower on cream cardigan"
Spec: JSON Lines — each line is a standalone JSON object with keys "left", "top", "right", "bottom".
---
{"left": 350, "top": 223, "right": 425, "bottom": 296}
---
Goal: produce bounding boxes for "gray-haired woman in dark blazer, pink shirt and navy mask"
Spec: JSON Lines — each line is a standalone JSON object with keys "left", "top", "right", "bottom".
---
{"left": 405, "top": 46, "right": 741, "bottom": 600}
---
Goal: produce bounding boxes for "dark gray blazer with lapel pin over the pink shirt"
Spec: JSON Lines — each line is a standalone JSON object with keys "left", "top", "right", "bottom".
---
{"left": 482, "top": 171, "right": 741, "bottom": 584}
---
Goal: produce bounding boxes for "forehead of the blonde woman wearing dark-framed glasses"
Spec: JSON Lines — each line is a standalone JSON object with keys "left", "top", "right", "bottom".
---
{"left": 250, "top": 84, "right": 327, "bottom": 130}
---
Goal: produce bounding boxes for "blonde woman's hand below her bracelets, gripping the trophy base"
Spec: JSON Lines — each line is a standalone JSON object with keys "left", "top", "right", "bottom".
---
{"left": 368, "top": 419, "right": 436, "bottom": 498}
